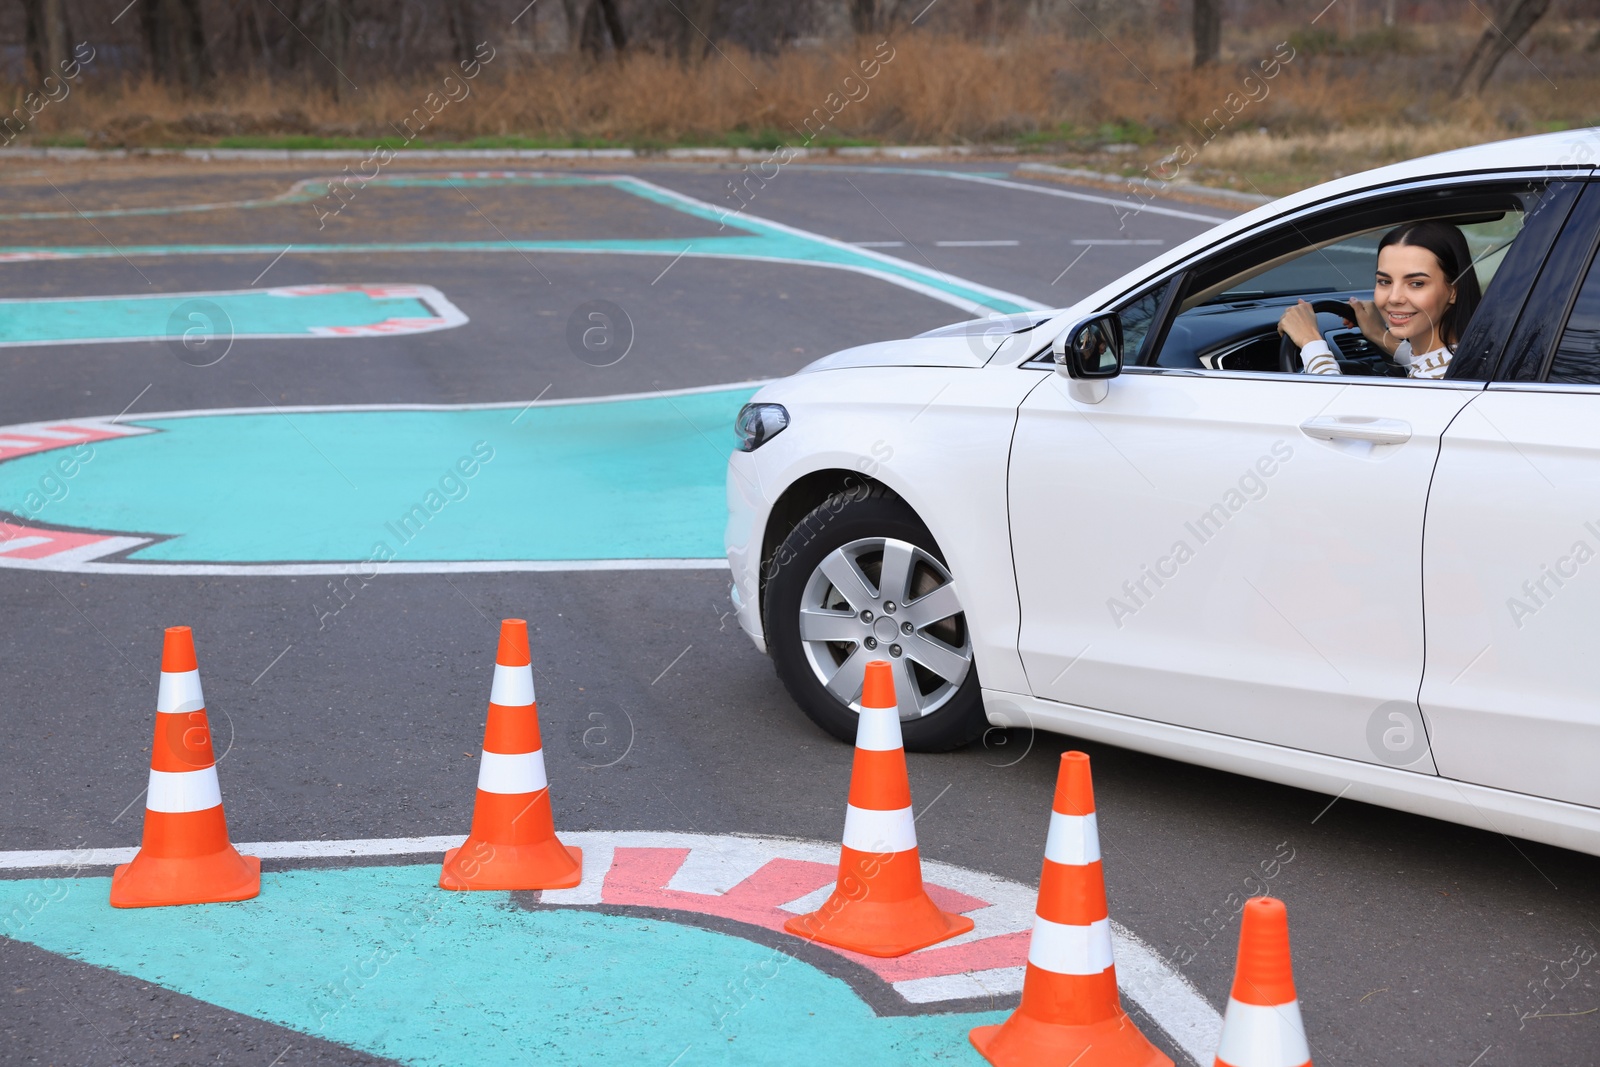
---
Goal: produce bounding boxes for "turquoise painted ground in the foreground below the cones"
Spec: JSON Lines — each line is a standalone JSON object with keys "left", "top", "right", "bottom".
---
{"left": 0, "top": 864, "right": 1005, "bottom": 1067}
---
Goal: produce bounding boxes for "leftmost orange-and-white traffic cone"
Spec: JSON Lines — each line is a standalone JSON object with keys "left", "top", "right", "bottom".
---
{"left": 110, "top": 625, "right": 261, "bottom": 907}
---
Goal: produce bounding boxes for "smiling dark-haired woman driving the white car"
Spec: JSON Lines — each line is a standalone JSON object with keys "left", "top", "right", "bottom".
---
{"left": 1278, "top": 219, "right": 1483, "bottom": 378}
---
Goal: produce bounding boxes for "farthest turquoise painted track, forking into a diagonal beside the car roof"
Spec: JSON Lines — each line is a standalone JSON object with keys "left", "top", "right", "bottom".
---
{"left": 0, "top": 173, "right": 1046, "bottom": 315}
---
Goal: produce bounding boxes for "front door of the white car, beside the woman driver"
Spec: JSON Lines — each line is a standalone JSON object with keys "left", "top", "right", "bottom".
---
{"left": 1010, "top": 186, "right": 1580, "bottom": 773}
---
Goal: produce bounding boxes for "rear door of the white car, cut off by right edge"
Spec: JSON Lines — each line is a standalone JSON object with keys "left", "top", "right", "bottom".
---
{"left": 1422, "top": 179, "right": 1600, "bottom": 806}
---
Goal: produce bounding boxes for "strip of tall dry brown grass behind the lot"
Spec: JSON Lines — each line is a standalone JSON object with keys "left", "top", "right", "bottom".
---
{"left": 0, "top": 26, "right": 1600, "bottom": 192}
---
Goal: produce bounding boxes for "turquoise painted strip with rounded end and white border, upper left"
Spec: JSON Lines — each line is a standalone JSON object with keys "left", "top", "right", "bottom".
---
{"left": 0, "top": 285, "right": 467, "bottom": 347}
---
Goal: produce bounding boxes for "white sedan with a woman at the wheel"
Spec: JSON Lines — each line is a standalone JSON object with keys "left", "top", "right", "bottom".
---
{"left": 726, "top": 130, "right": 1600, "bottom": 854}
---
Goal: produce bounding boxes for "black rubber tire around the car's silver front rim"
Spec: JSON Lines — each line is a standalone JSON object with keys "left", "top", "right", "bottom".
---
{"left": 762, "top": 485, "right": 989, "bottom": 752}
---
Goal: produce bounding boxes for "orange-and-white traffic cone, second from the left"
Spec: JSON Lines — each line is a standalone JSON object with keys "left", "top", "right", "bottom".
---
{"left": 438, "top": 619, "right": 584, "bottom": 889}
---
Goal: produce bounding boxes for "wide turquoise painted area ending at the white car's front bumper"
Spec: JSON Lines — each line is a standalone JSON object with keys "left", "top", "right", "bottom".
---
{"left": 0, "top": 386, "right": 755, "bottom": 563}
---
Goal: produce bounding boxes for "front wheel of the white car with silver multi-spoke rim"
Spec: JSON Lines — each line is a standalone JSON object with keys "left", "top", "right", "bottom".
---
{"left": 763, "top": 486, "right": 987, "bottom": 752}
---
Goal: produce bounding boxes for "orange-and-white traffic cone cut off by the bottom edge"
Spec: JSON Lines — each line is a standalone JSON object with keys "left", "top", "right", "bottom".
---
{"left": 1216, "top": 896, "right": 1310, "bottom": 1067}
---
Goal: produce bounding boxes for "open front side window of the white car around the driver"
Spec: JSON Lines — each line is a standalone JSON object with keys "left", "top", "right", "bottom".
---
{"left": 1139, "top": 182, "right": 1560, "bottom": 376}
